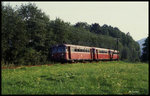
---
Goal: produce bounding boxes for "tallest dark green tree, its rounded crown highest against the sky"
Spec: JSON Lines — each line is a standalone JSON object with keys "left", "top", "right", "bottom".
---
{"left": 17, "top": 3, "right": 51, "bottom": 63}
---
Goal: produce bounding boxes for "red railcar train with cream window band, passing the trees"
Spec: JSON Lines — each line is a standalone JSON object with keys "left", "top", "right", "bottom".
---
{"left": 51, "top": 44, "right": 119, "bottom": 62}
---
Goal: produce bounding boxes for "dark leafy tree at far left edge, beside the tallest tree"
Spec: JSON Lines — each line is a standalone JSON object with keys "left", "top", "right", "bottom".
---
{"left": 2, "top": 5, "right": 27, "bottom": 64}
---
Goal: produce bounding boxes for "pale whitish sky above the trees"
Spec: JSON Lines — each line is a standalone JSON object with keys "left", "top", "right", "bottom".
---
{"left": 3, "top": 1, "right": 149, "bottom": 41}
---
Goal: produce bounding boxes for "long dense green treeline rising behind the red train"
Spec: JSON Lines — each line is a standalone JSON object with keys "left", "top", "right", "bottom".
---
{"left": 1, "top": 3, "right": 140, "bottom": 65}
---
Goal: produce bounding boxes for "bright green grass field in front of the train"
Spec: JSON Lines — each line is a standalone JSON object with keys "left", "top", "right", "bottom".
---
{"left": 1, "top": 61, "right": 149, "bottom": 95}
